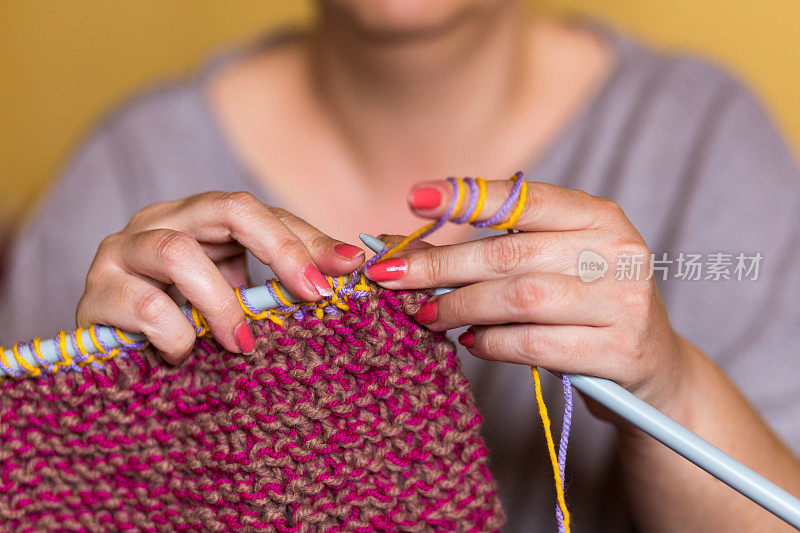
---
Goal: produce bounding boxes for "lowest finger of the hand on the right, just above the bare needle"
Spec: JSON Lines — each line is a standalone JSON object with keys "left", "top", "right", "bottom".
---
{"left": 459, "top": 324, "right": 616, "bottom": 381}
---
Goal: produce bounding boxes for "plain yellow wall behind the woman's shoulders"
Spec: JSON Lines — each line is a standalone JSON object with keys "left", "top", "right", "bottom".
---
{"left": 0, "top": 0, "right": 800, "bottom": 221}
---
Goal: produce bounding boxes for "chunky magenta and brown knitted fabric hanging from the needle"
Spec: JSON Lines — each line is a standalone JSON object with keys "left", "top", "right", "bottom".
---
{"left": 0, "top": 285, "right": 504, "bottom": 531}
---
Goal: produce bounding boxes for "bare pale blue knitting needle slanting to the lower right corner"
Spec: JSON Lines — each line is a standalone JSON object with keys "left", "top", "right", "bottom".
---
{"left": 359, "top": 233, "right": 800, "bottom": 529}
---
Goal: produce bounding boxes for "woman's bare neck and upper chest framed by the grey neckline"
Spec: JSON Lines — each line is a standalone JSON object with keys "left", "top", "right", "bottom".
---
{"left": 209, "top": 6, "right": 611, "bottom": 239}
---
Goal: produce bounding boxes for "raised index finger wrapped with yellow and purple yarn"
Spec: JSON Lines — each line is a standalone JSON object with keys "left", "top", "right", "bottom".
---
{"left": 409, "top": 180, "right": 624, "bottom": 231}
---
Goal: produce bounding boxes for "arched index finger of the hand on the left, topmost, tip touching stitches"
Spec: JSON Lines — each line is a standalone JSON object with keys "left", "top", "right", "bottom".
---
{"left": 129, "top": 191, "right": 333, "bottom": 301}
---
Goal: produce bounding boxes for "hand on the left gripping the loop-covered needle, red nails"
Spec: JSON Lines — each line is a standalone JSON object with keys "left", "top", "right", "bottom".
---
{"left": 77, "top": 192, "right": 364, "bottom": 363}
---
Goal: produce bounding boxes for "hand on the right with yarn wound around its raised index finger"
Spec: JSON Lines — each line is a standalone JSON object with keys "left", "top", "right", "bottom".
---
{"left": 367, "top": 181, "right": 693, "bottom": 408}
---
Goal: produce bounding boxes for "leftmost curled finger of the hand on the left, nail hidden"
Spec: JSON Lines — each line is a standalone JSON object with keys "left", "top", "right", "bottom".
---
{"left": 76, "top": 269, "right": 196, "bottom": 364}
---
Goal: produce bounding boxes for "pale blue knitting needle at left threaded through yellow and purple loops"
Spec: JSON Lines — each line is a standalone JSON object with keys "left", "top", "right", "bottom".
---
{"left": 0, "top": 284, "right": 298, "bottom": 377}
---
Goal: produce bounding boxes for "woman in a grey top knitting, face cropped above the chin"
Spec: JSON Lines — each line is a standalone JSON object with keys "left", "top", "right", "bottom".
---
{"left": 3, "top": 0, "right": 800, "bottom": 531}
